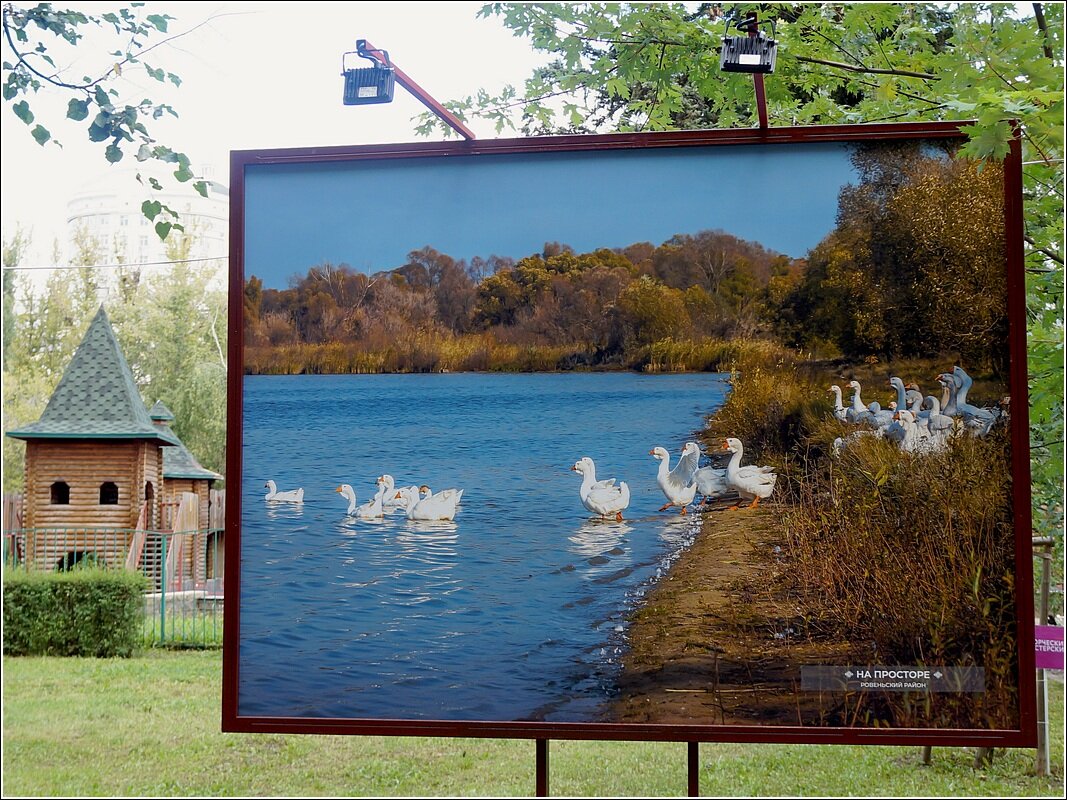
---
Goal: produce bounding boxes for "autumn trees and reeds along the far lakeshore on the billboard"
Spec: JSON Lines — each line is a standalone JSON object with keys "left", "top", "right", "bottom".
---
{"left": 243, "top": 143, "right": 1007, "bottom": 373}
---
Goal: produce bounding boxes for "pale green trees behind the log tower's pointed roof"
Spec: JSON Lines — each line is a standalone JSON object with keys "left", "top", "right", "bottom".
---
{"left": 3, "top": 226, "right": 226, "bottom": 492}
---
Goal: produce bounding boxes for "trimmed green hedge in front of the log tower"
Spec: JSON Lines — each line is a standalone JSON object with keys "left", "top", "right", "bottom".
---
{"left": 3, "top": 569, "right": 147, "bottom": 658}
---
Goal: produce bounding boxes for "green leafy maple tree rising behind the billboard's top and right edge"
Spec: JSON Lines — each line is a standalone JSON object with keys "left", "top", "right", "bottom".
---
{"left": 420, "top": 2, "right": 1064, "bottom": 533}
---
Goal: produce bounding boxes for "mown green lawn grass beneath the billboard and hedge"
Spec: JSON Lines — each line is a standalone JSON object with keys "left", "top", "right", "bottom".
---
{"left": 3, "top": 651, "right": 1064, "bottom": 797}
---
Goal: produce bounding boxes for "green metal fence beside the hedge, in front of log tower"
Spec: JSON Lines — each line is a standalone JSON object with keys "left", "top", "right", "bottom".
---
{"left": 3, "top": 491, "right": 225, "bottom": 647}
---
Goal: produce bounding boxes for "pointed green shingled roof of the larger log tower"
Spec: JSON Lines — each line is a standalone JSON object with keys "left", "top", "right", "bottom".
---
{"left": 7, "top": 306, "right": 181, "bottom": 445}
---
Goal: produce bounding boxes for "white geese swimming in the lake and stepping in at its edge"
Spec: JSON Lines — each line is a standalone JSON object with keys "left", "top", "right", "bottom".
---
{"left": 264, "top": 438, "right": 778, "bottom": 522}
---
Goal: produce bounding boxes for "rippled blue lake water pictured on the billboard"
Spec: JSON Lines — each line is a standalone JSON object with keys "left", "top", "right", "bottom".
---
{"left": 238, "top": 373, "right": 727, "bottom": 722}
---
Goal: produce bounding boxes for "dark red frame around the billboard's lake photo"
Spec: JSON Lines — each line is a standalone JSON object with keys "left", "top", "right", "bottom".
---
{"left": 222, "top": 122, "right": 1037, "bottom": 748}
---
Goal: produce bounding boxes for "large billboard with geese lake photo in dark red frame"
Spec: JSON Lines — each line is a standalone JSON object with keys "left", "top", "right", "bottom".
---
{"left": 223, "top": 123, "right": 1035, "bottom": 746}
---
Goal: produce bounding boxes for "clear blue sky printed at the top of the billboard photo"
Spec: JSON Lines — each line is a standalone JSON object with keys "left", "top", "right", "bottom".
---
{"left": 244, "top": 143, "right": 856, "bottom": 288}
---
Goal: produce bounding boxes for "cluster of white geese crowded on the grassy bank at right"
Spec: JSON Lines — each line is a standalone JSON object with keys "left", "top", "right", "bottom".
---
{"left": 829, "top": 366, "right": 1006, "bottom": 454}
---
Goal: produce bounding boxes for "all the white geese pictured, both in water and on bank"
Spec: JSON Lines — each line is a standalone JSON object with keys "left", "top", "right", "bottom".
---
{"left": 258, "top": 366, "right": 1006, "bottom": 522}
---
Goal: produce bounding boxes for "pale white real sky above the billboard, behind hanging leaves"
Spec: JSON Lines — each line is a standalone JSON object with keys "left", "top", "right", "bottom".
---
{"left": 0, "top": 2, "right": 543, "bottom": 265}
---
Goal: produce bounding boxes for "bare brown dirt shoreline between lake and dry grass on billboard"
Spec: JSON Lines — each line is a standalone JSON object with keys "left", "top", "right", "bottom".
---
{"left": 609, "top": 506, "right": 857, "bottom": 725}
